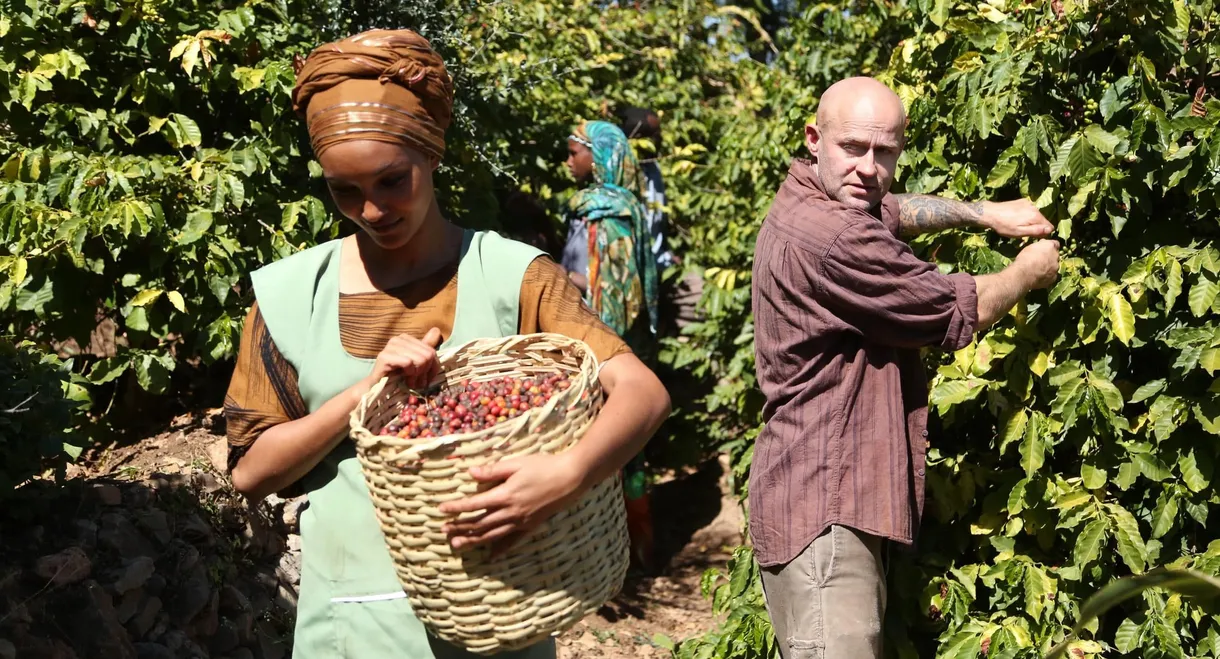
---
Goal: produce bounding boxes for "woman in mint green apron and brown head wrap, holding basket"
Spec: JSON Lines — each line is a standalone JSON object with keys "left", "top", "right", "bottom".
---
{"left": 224, "top": 31, "right": 669, "bottom": 659}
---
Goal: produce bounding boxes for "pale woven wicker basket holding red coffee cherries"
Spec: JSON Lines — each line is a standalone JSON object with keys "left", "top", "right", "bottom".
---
{"left": 351, "top": 334, "right": 630, "bottom": 654}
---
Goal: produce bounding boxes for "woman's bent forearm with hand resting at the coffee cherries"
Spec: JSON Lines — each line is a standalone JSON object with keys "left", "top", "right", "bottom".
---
{"left": 229, "top": 328, "right": 440, "bottom": 500}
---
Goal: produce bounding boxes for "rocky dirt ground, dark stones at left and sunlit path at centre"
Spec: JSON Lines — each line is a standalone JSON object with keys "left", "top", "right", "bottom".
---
{"left": 0, "top": 410, "right": 742, "bottom": 659}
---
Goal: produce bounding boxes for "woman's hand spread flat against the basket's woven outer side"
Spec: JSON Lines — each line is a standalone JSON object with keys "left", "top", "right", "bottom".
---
{"left": 440, "top": 455, "right": 584, "bottom": 554}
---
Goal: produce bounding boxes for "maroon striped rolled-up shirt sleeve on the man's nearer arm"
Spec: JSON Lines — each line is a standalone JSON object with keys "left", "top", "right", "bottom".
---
{"left": 811, "top": 217, "right": 978, "bottom": 350}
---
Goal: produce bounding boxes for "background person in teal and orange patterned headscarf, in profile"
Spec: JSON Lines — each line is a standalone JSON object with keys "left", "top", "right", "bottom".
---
{"left": 562, "top": 121, "right": 658, "bottom": 570}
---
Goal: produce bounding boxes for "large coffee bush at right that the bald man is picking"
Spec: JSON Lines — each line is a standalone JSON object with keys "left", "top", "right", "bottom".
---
{"left": 678, "top": 0, "right": 1220, "bottom": 658}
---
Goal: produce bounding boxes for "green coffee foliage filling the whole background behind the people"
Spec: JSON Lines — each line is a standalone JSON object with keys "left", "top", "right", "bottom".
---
{"left": 7, "top": 0, "right": 1220, "bottom": 658}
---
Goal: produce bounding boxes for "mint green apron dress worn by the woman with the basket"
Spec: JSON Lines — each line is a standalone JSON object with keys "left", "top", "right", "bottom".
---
{"left": 251, "top": 232, "right": 555, "bottom": 659}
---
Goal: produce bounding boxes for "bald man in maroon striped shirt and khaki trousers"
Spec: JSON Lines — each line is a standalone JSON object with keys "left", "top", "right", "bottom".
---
{"left": 749, "top": 78, "right": 1059, "bottom": 659}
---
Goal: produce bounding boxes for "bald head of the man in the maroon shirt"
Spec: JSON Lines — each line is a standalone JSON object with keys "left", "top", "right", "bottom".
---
{"left": 805, "top": 78, "right": 906, "bottom": 211}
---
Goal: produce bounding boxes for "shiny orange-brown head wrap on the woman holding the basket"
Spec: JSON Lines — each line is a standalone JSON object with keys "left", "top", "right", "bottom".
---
{"left": 293, "top": 29, "right": 454, "bottom": 159}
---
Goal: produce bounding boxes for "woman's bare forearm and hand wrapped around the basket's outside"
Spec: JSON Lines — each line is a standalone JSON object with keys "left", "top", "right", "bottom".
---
{"left": 440, "top": 353, "right": 670, "bottom": 550}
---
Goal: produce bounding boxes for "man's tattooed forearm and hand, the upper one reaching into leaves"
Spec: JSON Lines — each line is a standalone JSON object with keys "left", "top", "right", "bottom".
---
{"left": 894, "top": 194, "right": 1054, "bottom": 238}
